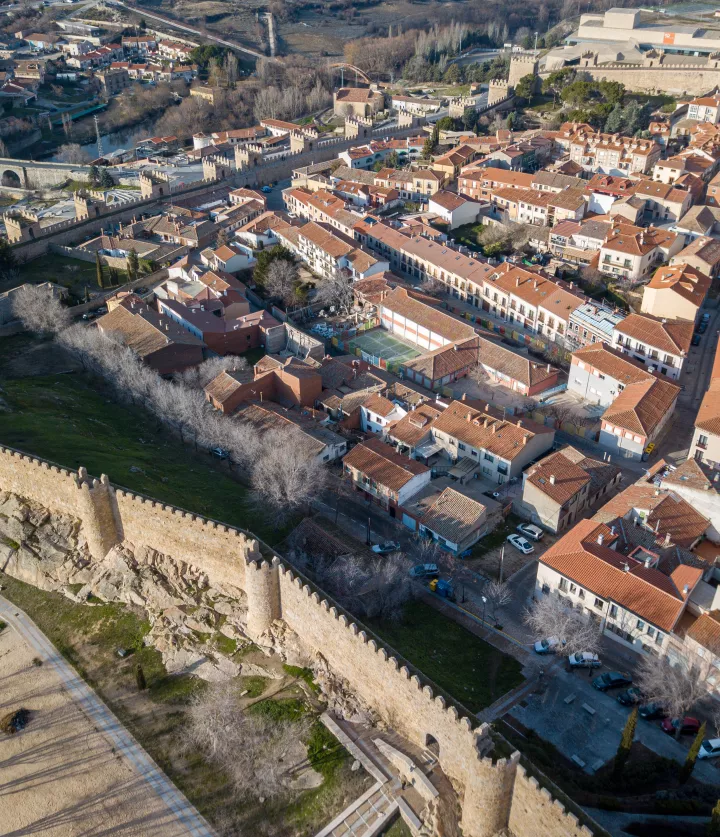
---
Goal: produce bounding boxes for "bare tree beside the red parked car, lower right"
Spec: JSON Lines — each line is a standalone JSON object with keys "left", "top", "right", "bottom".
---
{"left": 635, "top": 654, "right": 708, "bottom": 738}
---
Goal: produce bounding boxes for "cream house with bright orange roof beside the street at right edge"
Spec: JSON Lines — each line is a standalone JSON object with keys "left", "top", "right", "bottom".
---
{"left": 640, "top": 262, "right": 712, "bottom": 323}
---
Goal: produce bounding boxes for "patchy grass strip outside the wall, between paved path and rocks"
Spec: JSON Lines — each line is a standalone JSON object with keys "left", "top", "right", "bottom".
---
{"left": 0, "top": 572, "right": 371, "bottom": 837}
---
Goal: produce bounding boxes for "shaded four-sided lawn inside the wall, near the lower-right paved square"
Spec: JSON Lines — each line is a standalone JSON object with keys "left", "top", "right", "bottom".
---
{"left": 370, "top": 602, "right": 523, "bottom": 712}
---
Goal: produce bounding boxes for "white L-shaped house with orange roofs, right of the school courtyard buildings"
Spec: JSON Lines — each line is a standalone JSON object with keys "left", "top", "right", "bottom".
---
{"left": 568, "top": 343, "right": 680, "bottom": 459}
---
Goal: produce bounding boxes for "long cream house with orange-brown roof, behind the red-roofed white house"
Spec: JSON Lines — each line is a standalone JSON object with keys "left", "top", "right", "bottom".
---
{"left": 431, "top": 401, "right": 555, "bottom": 485}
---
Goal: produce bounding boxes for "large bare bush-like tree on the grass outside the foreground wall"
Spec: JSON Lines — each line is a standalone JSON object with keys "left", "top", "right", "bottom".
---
{"left": 185, "top": 681, "right": 310, "bottom": 797}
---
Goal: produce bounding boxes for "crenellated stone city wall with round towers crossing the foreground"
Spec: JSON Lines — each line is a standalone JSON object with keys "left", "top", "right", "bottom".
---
{"left": 0, "top": 448, "right": 592, "bottom": 837}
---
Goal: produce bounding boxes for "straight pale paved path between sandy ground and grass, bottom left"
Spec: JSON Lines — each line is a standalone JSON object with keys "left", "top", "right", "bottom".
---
{"left": 0, "top": 596, "right": 215, "bottom": 837}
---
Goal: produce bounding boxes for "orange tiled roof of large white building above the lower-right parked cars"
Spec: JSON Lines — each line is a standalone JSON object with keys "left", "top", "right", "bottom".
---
{"left": 540, "top": 520, "right": 701, "bottom": 631}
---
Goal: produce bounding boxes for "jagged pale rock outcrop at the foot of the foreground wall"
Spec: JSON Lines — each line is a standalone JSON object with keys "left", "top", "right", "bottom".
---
{"left": 0, "top": 492, "right": 258, "bottom": 680}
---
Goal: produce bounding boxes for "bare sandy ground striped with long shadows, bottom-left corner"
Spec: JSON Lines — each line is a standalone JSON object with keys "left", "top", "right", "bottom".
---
{"left": 0, "top": 616, "right": 198, "bottom": 837}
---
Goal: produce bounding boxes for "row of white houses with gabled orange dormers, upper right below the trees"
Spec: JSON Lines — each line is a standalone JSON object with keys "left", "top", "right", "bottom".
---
{"left": 569, "top": 130, "right": 662, "bottom": 175}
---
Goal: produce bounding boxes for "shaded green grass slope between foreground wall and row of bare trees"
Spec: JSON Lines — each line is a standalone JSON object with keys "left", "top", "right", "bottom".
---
{"left": 0, "top": 356, "right": 295, "bottom": 545}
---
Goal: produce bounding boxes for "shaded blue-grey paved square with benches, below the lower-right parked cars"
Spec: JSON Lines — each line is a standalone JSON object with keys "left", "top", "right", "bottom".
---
{"left": 507, "top": 658, "right": 720, "bottom": 783}
